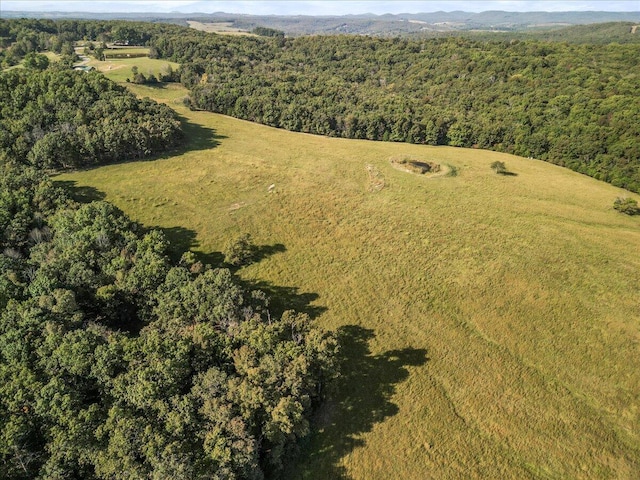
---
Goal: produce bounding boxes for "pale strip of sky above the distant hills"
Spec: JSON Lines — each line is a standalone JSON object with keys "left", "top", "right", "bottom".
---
{"left": 0, "top": 0, "right": 640, "bottom": 15}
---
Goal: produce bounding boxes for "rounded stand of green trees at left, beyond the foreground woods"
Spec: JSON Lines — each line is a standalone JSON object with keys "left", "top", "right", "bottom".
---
{"left": 0, "top": 66, "right": 183, "bottom": 169}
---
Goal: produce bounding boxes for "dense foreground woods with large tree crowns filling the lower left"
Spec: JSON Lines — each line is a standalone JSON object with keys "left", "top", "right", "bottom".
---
{"left": 0, "top": 170, "right": 336, "bottom": 480}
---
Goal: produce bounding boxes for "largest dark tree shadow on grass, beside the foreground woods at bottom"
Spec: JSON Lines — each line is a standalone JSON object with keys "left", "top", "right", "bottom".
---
{"left": 284, "top": 325, "right": 429, "bottom": 479}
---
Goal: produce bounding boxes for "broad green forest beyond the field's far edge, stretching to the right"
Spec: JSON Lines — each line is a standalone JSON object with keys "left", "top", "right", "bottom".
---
{"left": 151, "top": 32, "right": 640, "bottom": 191}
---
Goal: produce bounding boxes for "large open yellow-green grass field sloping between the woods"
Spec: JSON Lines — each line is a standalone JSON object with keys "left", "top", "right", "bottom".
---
{"left": 57, "top": 80, "right": 640, "bottom": 480}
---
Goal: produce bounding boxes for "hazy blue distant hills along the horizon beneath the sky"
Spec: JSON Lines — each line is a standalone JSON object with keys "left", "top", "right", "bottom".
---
{"left": 1, "top": 10, "right": 640, "bottom": 36}
